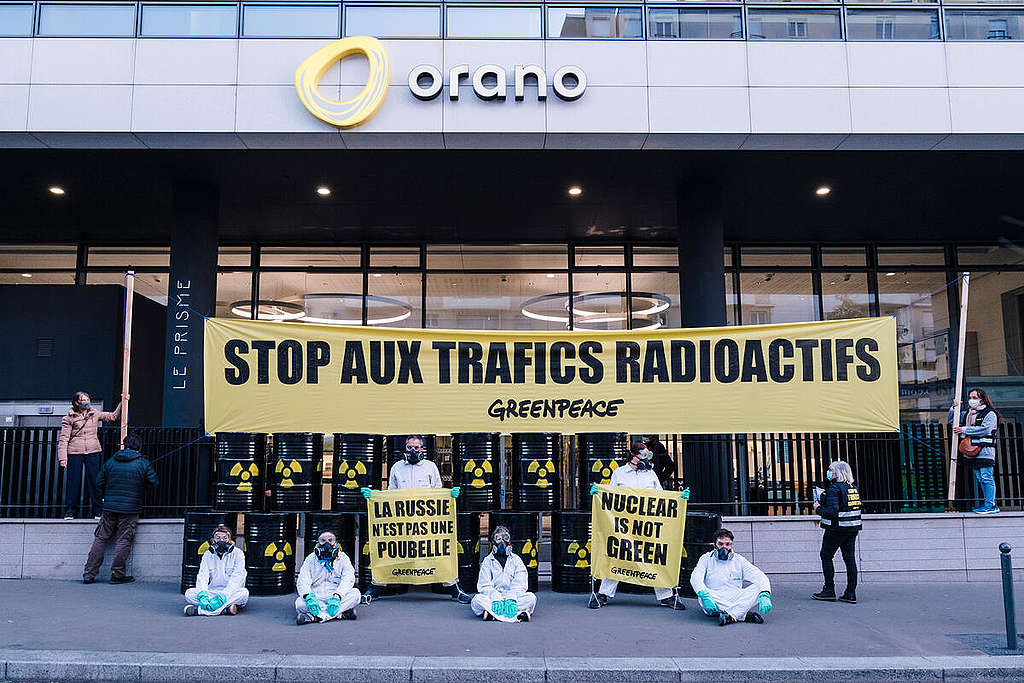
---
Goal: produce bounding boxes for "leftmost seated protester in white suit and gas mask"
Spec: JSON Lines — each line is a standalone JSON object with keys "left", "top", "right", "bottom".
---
{"left": 185, "top": 524, "right": 249, "bottom": 616}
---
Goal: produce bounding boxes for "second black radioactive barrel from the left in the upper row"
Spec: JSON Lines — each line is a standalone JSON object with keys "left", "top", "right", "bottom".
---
{"left": 269, "top": 432, "right": 324, "bottom": 512}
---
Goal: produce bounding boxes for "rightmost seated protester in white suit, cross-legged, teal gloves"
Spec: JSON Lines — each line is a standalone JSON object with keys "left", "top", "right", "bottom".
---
{"left": 690, "top": 528, "right": 772, "bottom": 626}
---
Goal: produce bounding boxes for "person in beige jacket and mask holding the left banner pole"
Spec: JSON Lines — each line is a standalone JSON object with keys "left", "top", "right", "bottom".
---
{"left": 57, "top": 391, "right": 125, "bottom": 519}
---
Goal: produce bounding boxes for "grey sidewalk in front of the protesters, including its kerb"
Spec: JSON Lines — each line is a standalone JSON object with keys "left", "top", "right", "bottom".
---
{"left": 6, "top": 580, "right": 1024, "bottom": 682}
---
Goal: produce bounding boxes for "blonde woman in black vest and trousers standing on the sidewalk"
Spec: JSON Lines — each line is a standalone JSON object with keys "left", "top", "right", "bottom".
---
{"left": 811, "top": 460, "right": 861, "bottom": 604}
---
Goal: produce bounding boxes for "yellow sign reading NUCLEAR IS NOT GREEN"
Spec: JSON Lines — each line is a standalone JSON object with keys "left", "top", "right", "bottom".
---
{"left": 591, "top": 484, "right": 686, "bottom": 588}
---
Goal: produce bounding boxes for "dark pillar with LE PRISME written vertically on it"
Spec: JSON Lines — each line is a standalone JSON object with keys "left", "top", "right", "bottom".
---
{"left": 163, "top": 180, "right": 219, "bottom": 427}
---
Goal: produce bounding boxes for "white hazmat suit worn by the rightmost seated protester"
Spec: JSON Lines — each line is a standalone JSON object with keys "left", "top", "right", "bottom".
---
{"left": 690, "top": 550, "right": 771, "bottom": 622}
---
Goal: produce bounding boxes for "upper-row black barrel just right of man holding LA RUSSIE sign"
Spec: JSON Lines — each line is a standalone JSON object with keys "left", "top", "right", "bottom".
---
{"left": 452, "top": 432, "right": 502, "bottom": 511}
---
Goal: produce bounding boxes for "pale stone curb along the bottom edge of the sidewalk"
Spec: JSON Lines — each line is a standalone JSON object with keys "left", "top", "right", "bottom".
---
{"left": 0, "top": 650, "right": 1024, "bottom": 683}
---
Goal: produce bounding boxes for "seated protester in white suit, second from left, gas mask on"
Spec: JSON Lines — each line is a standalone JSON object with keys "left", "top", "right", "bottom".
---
{"left": 295, "top": 531, "right": 360, "bottom": 626}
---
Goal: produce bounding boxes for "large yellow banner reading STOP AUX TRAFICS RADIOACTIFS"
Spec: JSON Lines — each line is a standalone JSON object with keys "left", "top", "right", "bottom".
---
{"left": 204, "top": 317, "right": 899, "bottom": 434}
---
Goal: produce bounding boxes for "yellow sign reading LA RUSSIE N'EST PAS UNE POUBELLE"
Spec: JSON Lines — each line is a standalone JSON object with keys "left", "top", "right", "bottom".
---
{"left": 367, "top": 488, "right": 459, "bottom": 584}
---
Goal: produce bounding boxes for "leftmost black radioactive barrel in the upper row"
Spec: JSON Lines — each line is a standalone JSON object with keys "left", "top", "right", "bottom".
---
{"left": 213, "top": 432, "right": 266, "bottom": 512}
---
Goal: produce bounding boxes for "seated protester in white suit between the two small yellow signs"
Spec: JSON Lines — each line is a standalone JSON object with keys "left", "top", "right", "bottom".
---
{"left": 472, "top": 526, "right": 537, "bottom": 622}
